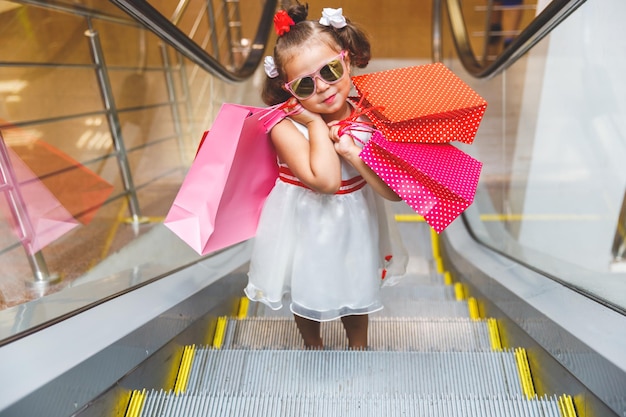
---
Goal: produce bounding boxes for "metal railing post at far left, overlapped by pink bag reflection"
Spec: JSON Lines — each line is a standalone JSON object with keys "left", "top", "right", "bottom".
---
{"left": 0, "top": 132, "right": 60, "bottom": 288}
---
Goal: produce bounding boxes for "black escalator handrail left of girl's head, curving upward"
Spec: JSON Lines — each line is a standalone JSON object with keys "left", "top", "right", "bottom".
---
{"left": 110, "top": 0, "right": 277, "bottom": 82}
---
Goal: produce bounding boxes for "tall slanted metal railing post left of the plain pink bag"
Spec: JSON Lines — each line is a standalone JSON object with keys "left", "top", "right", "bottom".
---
{"left": 85, "top": 18, "right": 143, "bottom": 224}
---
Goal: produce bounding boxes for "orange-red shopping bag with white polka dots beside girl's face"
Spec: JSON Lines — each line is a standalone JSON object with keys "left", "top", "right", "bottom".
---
{"left": 352, "top": 63, "right": 487, "bottom": 143}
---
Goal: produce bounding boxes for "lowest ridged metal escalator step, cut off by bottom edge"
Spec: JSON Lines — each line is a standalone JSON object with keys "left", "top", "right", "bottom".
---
{"left": 140, "top": 391, "right": 561, "bottom": 417}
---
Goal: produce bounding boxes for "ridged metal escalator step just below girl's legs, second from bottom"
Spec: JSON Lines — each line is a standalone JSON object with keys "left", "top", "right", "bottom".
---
{"left": 187, "top": 348, "right": 523, "bottom": 396}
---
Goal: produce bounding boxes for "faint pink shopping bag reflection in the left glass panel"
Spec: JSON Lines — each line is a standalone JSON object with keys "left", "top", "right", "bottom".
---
{"left": 0, "top": 135, "right": 79, "bottom": 255}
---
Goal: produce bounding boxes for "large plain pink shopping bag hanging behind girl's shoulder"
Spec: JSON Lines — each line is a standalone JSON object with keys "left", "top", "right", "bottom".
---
{"left": 164, "top": 103, "right": 285, "bottom": 255}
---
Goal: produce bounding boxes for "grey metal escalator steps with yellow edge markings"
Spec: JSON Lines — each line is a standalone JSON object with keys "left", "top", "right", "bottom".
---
{"left": 111, "top": 223, "right": 577, "bottom": 417}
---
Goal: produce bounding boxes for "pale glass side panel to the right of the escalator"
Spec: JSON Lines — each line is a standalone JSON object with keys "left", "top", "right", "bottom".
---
{"left": 438, "top": 1, "right": 626, "bottom": 310}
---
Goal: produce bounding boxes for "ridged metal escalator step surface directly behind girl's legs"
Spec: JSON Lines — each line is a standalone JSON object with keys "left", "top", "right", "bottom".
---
{"left": 222, "top": 317, "right": 492, "bottom": 351}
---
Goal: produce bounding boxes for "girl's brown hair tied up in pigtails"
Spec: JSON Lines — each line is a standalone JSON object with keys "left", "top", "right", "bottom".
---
{"left": 261, "top": 3, "right": 370, "bottom": 106}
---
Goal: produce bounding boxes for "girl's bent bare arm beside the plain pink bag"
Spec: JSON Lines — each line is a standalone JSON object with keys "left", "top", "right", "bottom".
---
{"left": 270, "top": 106, "right": 341, "bottom": 194}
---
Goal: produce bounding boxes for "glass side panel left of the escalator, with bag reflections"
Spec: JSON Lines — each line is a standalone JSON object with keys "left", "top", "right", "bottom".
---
{"left": 0, "top": 0, "right": 270, "bottom": 343}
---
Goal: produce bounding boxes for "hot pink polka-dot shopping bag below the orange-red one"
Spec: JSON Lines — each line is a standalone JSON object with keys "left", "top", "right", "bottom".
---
{"left": 360, "top": 131, "right": 482, "bottom": 233}
